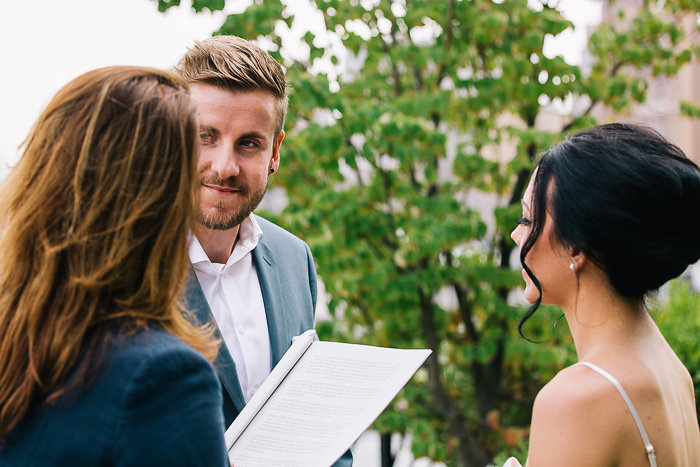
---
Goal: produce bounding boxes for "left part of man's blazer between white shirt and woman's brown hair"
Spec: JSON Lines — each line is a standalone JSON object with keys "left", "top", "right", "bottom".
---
{"left": 185, "top": 266, "right": 245, "bottom": 412}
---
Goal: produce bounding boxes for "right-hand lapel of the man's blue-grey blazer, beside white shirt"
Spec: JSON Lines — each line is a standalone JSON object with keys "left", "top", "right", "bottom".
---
{"left": 253, "top": 237, "right": 292, "bottom": 366}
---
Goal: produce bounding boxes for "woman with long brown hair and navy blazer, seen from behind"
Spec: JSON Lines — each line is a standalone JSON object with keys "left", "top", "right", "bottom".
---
{"left": 0, "top": 67, "right": 228, "bottom": 466}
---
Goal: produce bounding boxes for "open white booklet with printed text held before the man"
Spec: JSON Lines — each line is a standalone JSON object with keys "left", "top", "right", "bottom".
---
{"left": 226, "top": 330, "right": 431, "bottom": 467}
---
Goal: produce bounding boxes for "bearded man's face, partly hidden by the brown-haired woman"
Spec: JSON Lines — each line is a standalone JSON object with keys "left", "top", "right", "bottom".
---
{"left": 190, "top": 83, "right": 284, "bottom": 230}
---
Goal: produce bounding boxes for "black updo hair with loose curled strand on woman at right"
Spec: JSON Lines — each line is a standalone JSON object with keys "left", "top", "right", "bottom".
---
{"left": 518, "top": 123, "right": 700, "bottom": 335}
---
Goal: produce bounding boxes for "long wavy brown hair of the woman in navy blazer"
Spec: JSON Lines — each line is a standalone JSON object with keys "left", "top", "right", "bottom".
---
{"left": 0, "top": 67, "right": 217, "bottom": 442}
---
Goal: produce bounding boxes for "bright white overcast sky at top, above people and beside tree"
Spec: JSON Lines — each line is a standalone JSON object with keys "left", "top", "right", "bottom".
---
{"left": 0, "top": 0, "right": 600, "bottom": 178}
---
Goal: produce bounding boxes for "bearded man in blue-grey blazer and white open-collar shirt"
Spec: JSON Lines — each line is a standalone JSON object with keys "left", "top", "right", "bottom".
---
{"left": 176, "top": 36, "right": 352, "bottom": 465}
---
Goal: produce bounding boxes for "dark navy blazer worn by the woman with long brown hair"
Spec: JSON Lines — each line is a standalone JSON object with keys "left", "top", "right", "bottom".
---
{"left": 0, "top": 328, "right": 229, "bottom": 467}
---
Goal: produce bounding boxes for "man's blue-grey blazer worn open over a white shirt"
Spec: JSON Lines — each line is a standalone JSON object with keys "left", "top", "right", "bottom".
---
{"left": 185, "top": 216, "right": 352, "bottom": 467}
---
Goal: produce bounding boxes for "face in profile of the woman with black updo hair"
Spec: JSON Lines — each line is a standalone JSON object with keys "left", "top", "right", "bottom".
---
{"left": 510, "top": 170, "right": 575, "bottom": 305}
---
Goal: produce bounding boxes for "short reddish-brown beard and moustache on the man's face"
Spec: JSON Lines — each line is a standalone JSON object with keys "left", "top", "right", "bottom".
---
{"left": 199, "top": 176, "right": 267, "bottom": 230}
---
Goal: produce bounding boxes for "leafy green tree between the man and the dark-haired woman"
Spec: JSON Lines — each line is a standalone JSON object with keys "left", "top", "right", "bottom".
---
{"left": 158, "top": 0, "right": 700, "bottom": 466}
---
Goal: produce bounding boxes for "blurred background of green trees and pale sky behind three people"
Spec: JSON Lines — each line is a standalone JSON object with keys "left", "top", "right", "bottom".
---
{"left": 0, "top": 0, "right": 700, "bottom": 467}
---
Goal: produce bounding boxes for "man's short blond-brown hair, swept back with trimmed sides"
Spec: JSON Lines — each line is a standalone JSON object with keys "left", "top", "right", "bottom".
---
{"left": 175, "top": 36, "right": 288, "bottom": 136}
